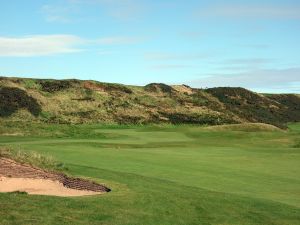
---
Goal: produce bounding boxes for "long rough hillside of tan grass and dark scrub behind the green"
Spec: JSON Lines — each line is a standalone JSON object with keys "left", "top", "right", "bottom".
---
{"left": 0, "top": 77, "right": 300, "bottom": 127}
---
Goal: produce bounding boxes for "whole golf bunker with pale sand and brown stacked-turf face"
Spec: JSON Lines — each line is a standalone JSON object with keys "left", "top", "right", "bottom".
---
{"left": 0, "top": 158, "right": 110, "bottom": 196}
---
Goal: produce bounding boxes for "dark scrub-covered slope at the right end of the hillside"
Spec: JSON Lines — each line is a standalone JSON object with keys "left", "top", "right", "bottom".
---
{"left": 206, "top": 87, "right": 300, "bottom": 128}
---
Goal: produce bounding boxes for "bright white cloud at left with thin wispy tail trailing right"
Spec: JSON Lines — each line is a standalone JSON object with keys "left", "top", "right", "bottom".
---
{"left": 0, "top": 34, "right": 140, "bottom": 57}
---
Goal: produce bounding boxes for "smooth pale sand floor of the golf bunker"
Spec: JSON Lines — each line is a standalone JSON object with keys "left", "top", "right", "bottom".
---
{"left": 0, "top": 177, "right": 101, "bottom": 197}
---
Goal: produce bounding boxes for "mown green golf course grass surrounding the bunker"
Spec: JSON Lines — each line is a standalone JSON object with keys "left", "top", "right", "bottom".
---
{"left": 0, "top": 124, "right": 300, "bottom": 225}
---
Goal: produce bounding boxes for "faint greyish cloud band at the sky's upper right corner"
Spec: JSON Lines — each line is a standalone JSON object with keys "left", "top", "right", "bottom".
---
{"left": 196, "top": 3, "right": 300, "bottom": 19}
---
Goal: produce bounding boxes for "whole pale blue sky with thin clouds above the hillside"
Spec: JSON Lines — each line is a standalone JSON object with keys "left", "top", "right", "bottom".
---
{"left": 0, "top": 0, "right": 300, "bottom": 93}
